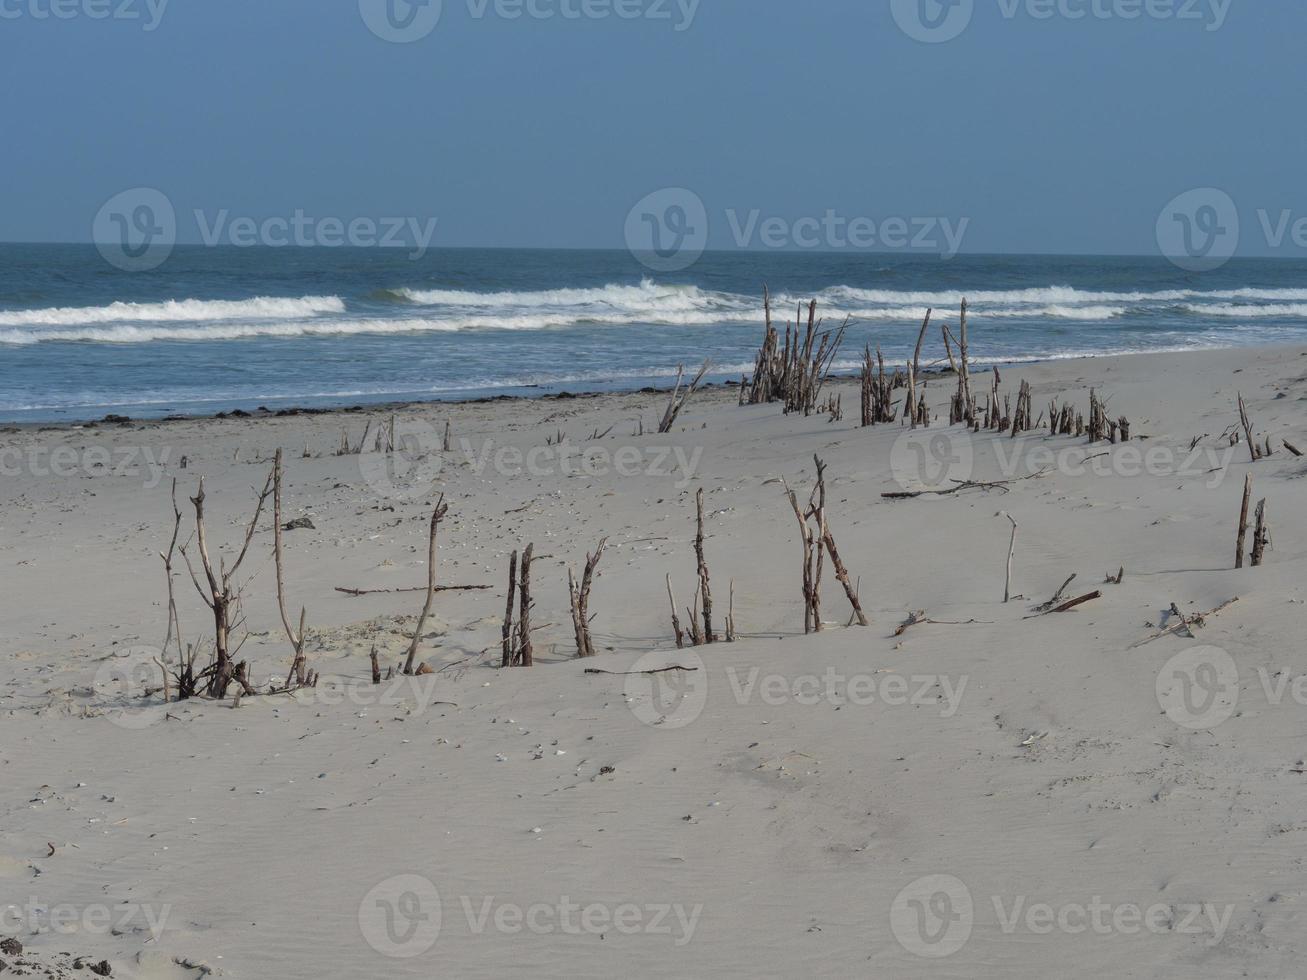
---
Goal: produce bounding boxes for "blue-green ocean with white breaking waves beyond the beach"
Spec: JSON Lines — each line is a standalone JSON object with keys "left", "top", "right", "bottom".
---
{"left": 0, "top": 244, "right": 1307, "bottom": 422}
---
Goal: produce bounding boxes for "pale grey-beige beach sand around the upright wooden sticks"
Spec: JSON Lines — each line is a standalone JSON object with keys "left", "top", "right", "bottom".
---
{"left": 0, "top": 348, "right": 1307, "bottom": 980}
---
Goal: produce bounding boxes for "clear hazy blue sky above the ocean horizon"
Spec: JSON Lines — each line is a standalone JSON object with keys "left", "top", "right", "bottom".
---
{"left": 0, "top": 0, "right": 1307, "bottom": 257}
